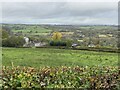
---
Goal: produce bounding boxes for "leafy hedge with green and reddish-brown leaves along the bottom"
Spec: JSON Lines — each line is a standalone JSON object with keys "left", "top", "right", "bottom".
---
{"left": 2, "top": 66, "right": 120, "bottom": 90}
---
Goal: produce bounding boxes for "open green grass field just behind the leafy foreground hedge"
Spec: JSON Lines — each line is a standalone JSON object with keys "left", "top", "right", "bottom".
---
{"left": 2, "top": 48, "right": 118, "bottom": 67}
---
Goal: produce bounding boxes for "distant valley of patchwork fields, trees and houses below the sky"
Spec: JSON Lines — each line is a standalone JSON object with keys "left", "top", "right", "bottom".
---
{"left": 3, "top": 24, "right": 119, "bottom": 48}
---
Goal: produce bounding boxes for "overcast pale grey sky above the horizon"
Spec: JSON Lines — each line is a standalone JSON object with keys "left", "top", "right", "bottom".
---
{"left": 0, "top": 0, "right": 118, "bottom": 25}
